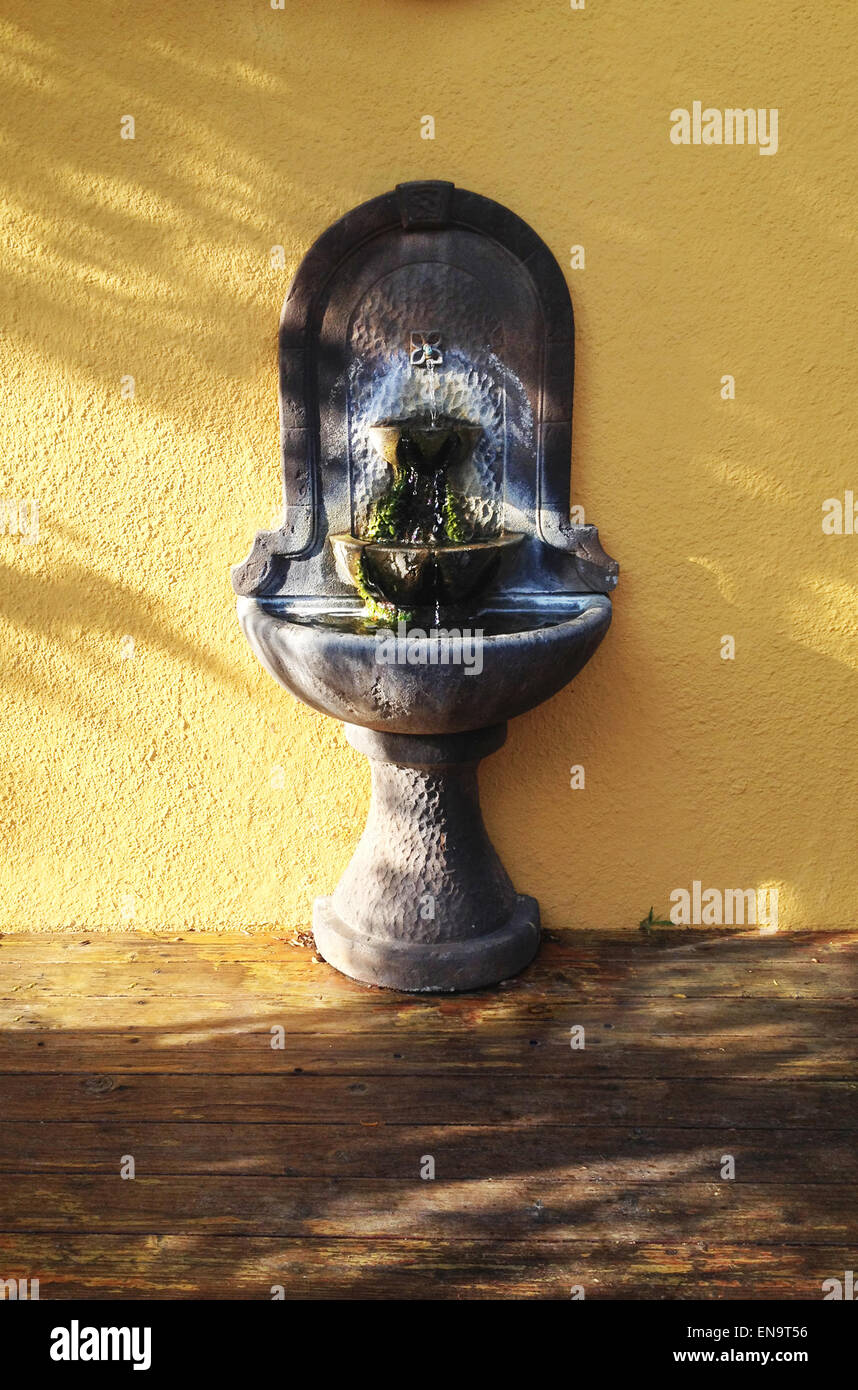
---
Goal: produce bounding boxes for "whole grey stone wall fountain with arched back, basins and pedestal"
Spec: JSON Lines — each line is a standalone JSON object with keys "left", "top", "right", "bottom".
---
{"left": 234, "top": 182, "right": 617, "bottom": 991}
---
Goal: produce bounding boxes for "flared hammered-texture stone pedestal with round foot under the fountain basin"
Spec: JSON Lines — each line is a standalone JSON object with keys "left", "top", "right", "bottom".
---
{"left": 313, "top": 724, "right": 540, "bottom": 992}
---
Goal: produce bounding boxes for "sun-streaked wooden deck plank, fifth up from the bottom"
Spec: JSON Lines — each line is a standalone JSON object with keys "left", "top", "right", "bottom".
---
{"left": 0, "top": 1028, "right": 858, "bottom": 1080}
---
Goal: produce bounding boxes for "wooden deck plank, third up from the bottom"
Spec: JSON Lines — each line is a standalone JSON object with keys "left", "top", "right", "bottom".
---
{"left": 0, "top": 1119, "right": 858, "bottom": 1178}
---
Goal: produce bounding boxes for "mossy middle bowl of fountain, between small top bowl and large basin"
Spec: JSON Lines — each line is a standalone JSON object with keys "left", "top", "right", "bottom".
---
{"left": 328, "top": 531, "right": 521, "bottom": 609}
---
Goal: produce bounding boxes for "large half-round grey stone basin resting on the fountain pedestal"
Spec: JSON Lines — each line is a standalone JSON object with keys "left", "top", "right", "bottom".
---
{"left": 238, "top": 594, "right": 610, "bottom": 734}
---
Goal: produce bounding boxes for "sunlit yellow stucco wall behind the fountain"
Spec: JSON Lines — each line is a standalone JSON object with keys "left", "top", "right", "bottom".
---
{"left": 0, "top": 0, "right": 858, "bottom": 930}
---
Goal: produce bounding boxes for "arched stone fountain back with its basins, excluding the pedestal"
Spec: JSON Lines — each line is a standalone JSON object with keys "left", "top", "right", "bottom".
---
{"left": 234, "top": 182, "right": 617, "bottom": 734}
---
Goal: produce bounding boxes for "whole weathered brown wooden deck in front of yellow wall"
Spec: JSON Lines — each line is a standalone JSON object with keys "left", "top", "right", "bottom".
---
{"left": 0, "top": 930, "right": 858, "bottom": 1300}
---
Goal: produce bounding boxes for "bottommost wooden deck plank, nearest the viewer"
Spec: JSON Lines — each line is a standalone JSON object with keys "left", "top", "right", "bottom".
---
{"left": 0, "top": 1233, "right": 855, "bottom": 1300}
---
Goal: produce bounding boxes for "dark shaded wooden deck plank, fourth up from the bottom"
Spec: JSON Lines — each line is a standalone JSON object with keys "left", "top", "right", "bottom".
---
{"left": 0, "top": 1072, "right": 858, "bottom": 1130}
